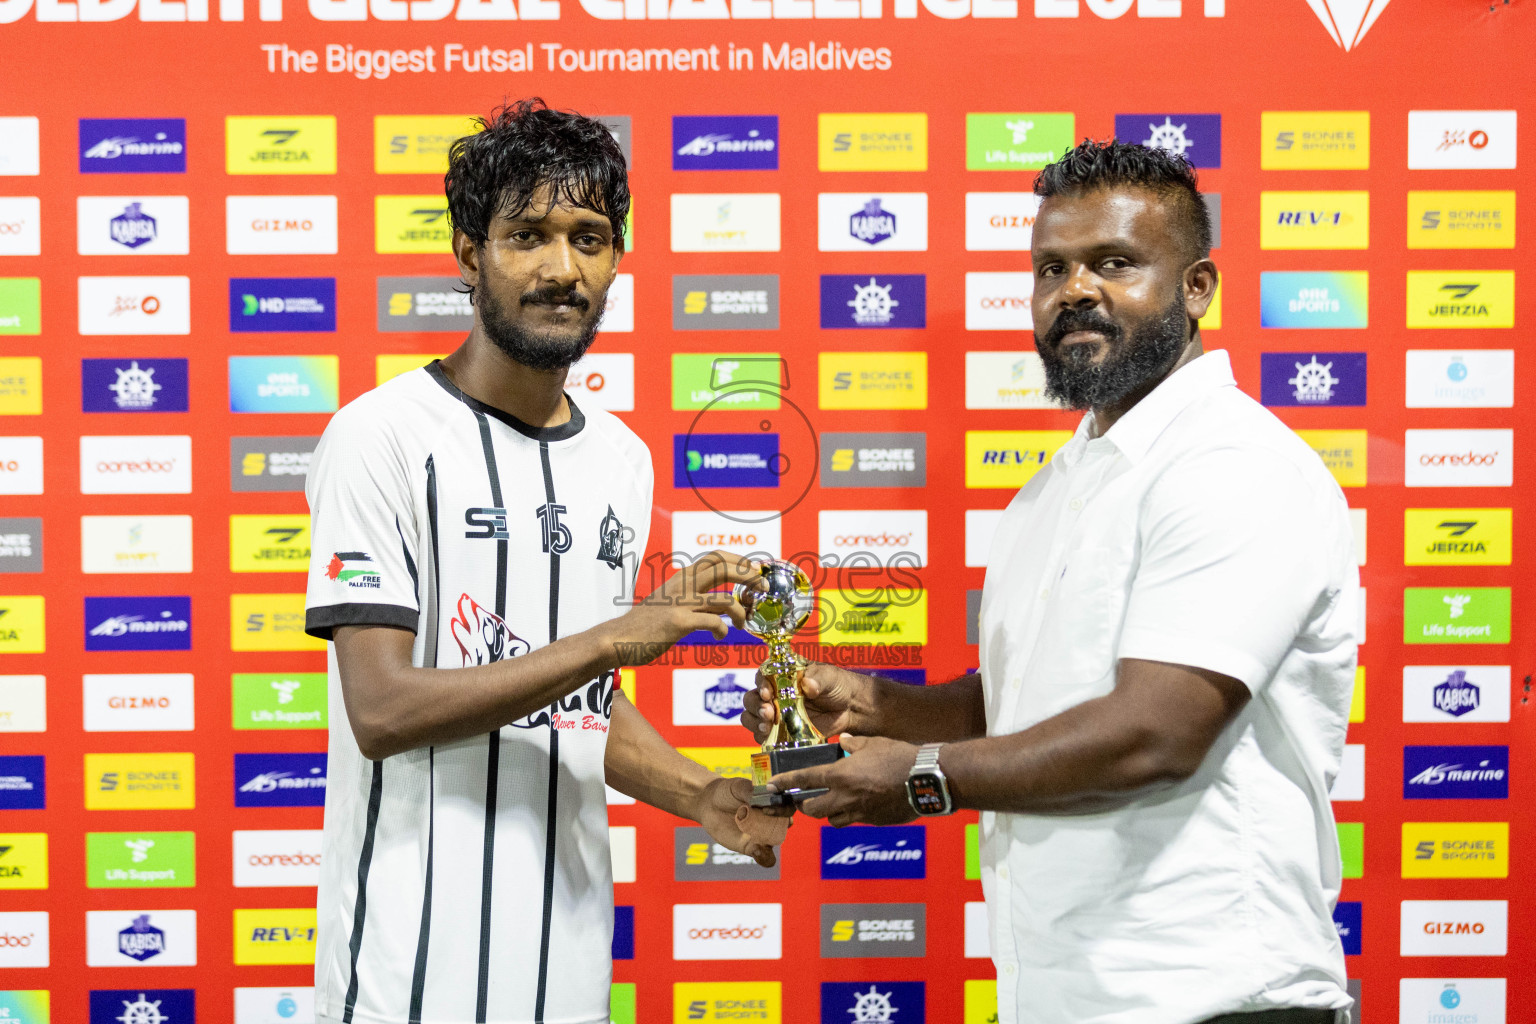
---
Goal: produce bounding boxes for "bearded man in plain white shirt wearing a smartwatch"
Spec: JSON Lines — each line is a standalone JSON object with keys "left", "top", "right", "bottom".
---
{"left": 743, "top": 143, "right": 1358, "bottom": 1024}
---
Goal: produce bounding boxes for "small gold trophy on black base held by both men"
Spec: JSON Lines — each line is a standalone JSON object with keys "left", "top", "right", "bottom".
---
{"left": 736, "top": 560, "right": 843, "bottom": 808}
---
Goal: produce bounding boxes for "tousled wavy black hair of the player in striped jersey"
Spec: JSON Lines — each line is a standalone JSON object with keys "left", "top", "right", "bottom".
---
{"left": 442, "top": 97, "right": 630, "bottom": 252}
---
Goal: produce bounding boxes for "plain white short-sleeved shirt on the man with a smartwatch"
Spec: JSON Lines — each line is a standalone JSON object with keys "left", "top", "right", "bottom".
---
{"left": 980, "top": 352, "right": 1359, "bottom": 1024}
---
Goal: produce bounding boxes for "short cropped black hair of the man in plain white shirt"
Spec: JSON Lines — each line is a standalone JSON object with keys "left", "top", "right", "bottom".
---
{"left": 1035, "top": 138, "right": 1210, "bottom": 263}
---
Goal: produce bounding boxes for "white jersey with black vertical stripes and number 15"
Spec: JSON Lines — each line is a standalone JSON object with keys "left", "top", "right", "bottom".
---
{"left": 306, "top": 362, "right": 653, "bottom": 1024}
